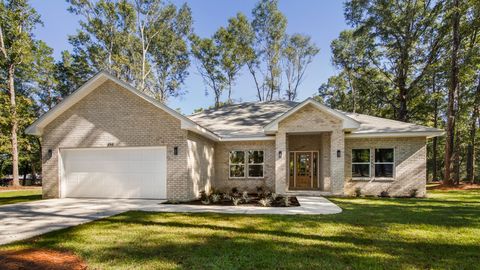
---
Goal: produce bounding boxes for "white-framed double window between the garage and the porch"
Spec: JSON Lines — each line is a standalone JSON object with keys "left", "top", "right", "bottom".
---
{"left": 229, "top": 150, "right": 264, "bottom": 178}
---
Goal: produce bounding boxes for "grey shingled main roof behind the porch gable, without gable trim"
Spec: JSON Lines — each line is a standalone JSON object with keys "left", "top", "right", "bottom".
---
{"left": 189, "top": 99, "right": 444, "bottom": 139}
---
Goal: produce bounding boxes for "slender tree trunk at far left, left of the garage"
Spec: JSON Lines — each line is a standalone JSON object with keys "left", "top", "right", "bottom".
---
{"left": 8, "top": 65, "right": 20, "bottom": 187}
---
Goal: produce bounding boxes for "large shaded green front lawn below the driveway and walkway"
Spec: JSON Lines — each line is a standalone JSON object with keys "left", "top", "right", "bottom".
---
{"left": 3, "top": 190, "right": 480, "bottom": 269}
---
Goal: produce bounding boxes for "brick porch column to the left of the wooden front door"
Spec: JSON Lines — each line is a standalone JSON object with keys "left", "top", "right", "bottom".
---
{"left": 275, "top": 132, "right": 288, "bottom": 194}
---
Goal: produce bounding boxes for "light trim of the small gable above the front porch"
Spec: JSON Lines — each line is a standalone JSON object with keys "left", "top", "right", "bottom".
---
{"left": 264, "top": 98, "right": 360, "bottom": 134}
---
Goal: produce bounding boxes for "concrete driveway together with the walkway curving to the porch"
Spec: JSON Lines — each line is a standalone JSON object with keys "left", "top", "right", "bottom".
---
{"left": 0, "top": 196, "right": 342, "bottom": 245}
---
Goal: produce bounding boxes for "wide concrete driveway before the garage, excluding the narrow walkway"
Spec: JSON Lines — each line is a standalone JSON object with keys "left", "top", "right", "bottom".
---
{"left": 0, "top": 199, "right": 162, "bottom": 245}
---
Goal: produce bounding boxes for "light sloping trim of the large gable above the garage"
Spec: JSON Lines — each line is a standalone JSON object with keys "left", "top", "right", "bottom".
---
{"left": 25, "top": 71, "right": 218, "bottom": 140}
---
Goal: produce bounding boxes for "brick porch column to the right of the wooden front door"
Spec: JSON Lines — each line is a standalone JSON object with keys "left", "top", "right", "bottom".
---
{"left": 330, "top": 130, "right": 345, "bottom": 195}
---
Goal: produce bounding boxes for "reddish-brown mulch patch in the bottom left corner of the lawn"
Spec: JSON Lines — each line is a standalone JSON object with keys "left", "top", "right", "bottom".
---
{"left": 0, "top": 249, "right": 87, "bottom": 270}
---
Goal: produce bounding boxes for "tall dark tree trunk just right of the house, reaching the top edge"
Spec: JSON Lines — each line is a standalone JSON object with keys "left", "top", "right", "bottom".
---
{"left": 443, "top": 0, "right": 460, "bottom": 185}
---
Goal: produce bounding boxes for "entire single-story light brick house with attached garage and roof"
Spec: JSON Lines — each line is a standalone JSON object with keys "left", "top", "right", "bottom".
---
{"left": 27, "top": 72, "right": 443, "bottom": 200}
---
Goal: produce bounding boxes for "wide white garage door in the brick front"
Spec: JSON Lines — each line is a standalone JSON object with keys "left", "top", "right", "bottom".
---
{"left": 61, "top": 147, "right": 167, "bottom": 199}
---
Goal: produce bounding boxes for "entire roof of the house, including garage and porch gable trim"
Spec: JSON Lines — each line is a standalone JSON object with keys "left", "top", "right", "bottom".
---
{"left": 26, "top": 71, "right": 444, "bottom": 141}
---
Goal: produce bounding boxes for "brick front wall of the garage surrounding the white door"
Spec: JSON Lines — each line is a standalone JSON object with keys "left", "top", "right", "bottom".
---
{"left": 42, "top": 81, "right": 192, "bottom": 199}
